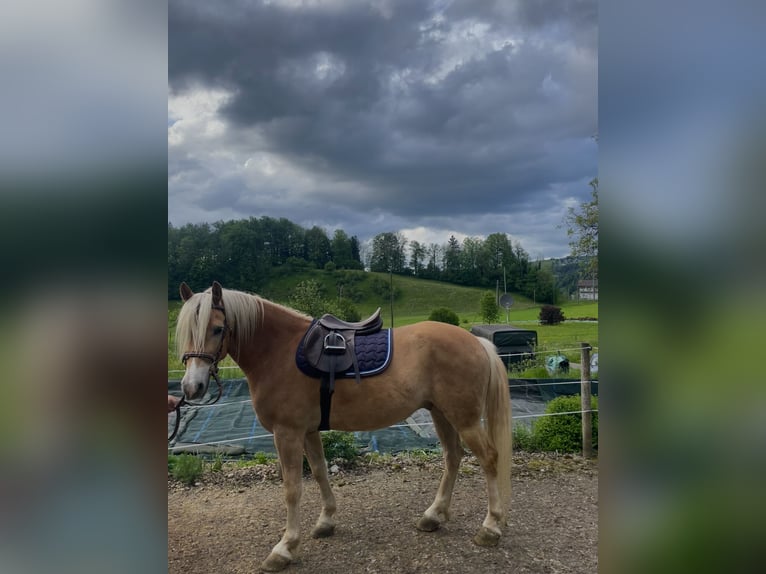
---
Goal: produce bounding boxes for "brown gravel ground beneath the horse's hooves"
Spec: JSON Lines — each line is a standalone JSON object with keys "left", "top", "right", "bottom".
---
{"left": 168, "top": 454, "right": 598, "bottom": 574}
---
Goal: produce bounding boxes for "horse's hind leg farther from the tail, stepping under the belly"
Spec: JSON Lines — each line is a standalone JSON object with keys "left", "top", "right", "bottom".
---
{"left": 417, "top": 408, "right": 464, "bottom": 532}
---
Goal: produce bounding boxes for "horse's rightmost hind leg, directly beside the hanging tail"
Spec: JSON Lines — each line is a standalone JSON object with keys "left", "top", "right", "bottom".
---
{"left": 460, "top": 423, "right": 504, "bottom": 546}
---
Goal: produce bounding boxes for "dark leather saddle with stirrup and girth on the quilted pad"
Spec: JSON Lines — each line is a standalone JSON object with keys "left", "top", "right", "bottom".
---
{"left": 302, "top": 307, "right": 383, "bottom": 430}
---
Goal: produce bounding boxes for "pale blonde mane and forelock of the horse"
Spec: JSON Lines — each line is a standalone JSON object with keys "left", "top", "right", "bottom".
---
{"left": 176, "top": 288, "right": 264, "bottom": 357}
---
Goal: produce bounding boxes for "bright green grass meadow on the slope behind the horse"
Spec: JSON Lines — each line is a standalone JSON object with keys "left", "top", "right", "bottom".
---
{"left": 168, "top": 276, "right": 598, "bottom": 378}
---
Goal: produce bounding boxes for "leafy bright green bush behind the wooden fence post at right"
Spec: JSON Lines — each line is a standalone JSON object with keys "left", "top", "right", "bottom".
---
{"left": 532, "top": 395, "right": 598, "bottom": 452}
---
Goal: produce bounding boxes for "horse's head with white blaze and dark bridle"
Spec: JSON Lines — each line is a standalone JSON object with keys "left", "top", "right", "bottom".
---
{"left": 176, "top": 281, "right": 230, "bottom": 400}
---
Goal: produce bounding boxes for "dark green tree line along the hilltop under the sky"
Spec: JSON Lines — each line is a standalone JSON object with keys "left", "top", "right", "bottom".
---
{"left": 168, "top": 217, "right": 558, "bottom": 303}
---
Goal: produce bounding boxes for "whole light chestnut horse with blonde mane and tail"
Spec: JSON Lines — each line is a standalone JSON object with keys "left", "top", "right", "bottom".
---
{"left": 176, "top": 282, "right": 511, "bottom": 571}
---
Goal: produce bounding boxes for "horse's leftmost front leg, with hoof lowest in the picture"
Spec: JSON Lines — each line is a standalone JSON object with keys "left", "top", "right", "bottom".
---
{"left": 261, "top": 429, "right": 303, "bottom": 572}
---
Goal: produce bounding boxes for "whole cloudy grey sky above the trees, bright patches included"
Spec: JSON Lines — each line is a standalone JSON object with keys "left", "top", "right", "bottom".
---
{"left": 168, "top": 0, "right": 598, "bottom": 258}
